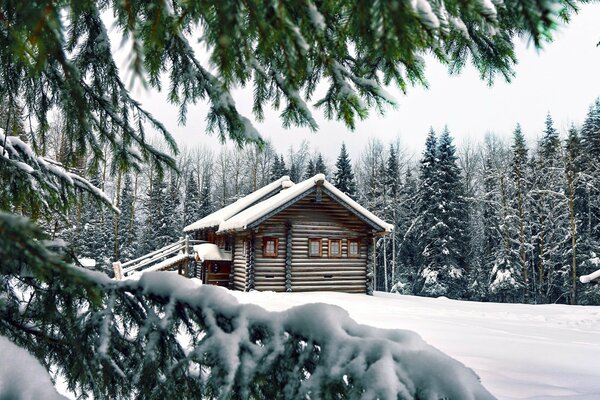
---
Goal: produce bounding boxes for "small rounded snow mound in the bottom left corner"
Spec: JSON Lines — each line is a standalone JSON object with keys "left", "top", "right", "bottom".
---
{"left": 0, "top": 336, "right": 65, "bottom": 400}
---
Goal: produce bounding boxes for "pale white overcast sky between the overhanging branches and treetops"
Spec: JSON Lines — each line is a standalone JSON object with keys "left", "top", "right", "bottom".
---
{"left": 123, "top": 4, "right": 600, "bottom": 161}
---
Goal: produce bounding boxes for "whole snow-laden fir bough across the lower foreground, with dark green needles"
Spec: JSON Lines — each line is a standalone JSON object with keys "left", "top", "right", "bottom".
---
{"left": 0, "top": 214, "right": 492, "bottom": 399}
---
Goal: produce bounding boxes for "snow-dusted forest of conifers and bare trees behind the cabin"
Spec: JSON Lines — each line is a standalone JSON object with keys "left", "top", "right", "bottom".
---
{"left": 29, "top": 100, "right": 600, "bottom": 304}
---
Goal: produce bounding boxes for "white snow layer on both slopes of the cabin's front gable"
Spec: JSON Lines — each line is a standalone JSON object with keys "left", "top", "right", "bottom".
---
{"left": 219, "top": 174, "right": 394, "bottom": 232}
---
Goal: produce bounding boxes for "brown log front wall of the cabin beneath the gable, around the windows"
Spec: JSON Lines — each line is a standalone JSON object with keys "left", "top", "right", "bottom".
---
{"left": 250, "top": 193, "right": 370, "bottom": 293}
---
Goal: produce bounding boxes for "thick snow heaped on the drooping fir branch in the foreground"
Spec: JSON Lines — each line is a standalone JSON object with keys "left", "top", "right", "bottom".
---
{"left": 125, "top": 273, "right": 493, "bottom": 400}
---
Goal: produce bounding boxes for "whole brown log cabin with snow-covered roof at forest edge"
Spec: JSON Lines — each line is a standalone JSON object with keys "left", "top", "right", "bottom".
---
{"left": 184, "top": 174, "right": 393, "bottom": 294}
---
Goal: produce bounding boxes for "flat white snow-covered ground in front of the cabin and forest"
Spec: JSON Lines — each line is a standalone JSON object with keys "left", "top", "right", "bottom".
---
{"left": 230, "top": 291, "right": 600, "bottom": 400}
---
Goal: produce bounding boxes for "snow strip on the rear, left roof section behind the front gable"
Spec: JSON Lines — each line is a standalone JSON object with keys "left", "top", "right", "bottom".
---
{"left": 183, "top": 175, "right": 294, "bottom": 232}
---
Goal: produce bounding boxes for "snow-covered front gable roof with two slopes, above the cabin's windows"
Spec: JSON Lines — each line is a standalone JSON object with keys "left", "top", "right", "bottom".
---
{"left": 219, "top": 174, "right": 393, "bottom": 232}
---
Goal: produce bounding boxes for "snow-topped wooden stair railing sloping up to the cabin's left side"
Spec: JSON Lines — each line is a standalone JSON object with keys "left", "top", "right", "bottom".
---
{"left": 113, "top": 235, "right": 206, "bottom": 280}
